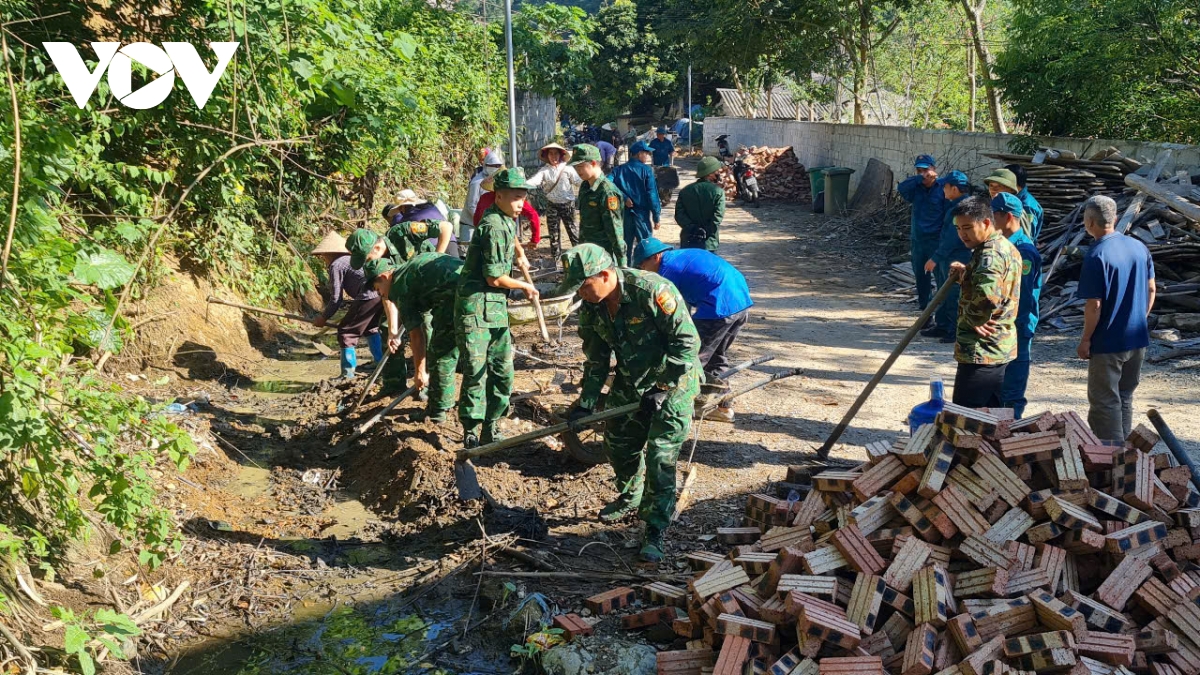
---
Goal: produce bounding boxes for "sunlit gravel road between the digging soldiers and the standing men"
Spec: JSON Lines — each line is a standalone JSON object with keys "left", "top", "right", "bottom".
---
{"left": 660, "top": 158, "right": 1200, "bottom": 509}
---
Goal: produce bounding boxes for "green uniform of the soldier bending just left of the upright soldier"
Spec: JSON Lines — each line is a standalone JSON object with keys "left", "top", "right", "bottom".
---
{"left": 366, "top": 252, "right": 463, "bottom": 422}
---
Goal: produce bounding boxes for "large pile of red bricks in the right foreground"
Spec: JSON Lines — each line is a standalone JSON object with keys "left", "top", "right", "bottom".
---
{"left": 556, "top": 405, "right": 1200, "bottom": 675}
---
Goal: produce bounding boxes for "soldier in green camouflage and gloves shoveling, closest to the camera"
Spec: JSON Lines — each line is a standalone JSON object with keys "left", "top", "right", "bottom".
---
{"left": 562, "top": 244, "right": 703, "bottom": 562}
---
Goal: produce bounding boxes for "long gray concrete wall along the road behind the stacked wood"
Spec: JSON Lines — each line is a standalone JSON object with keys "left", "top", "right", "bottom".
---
{"left": 704, "top": 118, "right": 1200, "bottom": 191}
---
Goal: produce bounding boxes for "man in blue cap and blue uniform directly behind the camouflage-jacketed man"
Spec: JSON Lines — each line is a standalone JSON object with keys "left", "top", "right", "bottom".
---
{"left": 991, "top": 192, "right": 1042, "bottom": 419}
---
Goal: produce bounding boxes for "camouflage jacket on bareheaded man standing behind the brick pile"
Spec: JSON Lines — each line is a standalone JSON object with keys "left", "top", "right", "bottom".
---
{"left": 954, "top": 232, "right": 1021, "bottom": 365}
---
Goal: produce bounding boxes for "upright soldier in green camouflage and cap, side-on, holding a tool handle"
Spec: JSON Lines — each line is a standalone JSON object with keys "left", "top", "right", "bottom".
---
{"left": 454, "top": 168, "right": 538, "bottom": 448}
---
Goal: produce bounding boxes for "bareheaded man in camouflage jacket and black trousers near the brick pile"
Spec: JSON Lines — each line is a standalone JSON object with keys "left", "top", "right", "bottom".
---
{"left": 950, "top": 197, "right": 1021, "bottom": 408}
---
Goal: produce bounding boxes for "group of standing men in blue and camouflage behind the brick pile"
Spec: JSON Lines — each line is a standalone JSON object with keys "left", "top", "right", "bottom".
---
{"left": 898, "top": 155, "right": 1154, "bottom": 441}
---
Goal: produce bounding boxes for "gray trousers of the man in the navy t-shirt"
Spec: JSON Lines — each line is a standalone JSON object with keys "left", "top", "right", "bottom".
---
{"left": 1087, "top": 347, "right": 1146, "bottom": 441}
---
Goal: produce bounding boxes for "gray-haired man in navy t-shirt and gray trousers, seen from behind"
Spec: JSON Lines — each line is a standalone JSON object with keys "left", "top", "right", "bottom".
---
{"left": 1075, "top": 195, "right": 1154, "bottom": 441}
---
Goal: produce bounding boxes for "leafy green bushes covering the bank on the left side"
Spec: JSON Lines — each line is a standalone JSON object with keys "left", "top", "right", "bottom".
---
{"left": 0, "top": 0, "right": 504, "bottom": 605}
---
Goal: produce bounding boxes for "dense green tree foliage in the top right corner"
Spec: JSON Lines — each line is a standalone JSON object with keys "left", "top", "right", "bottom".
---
{"left": 996, "top": 0, "right": 1200, "bottom": 143}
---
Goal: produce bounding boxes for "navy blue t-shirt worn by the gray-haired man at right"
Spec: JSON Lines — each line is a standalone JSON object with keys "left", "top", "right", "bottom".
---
{"left": 1076, "top": 232, "right": 1154, "bottom": 354}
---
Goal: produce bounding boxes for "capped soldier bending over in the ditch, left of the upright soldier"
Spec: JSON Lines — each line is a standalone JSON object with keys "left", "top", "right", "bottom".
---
{"left": 365, "top": 252, "right": 462, "bottom": 423}
